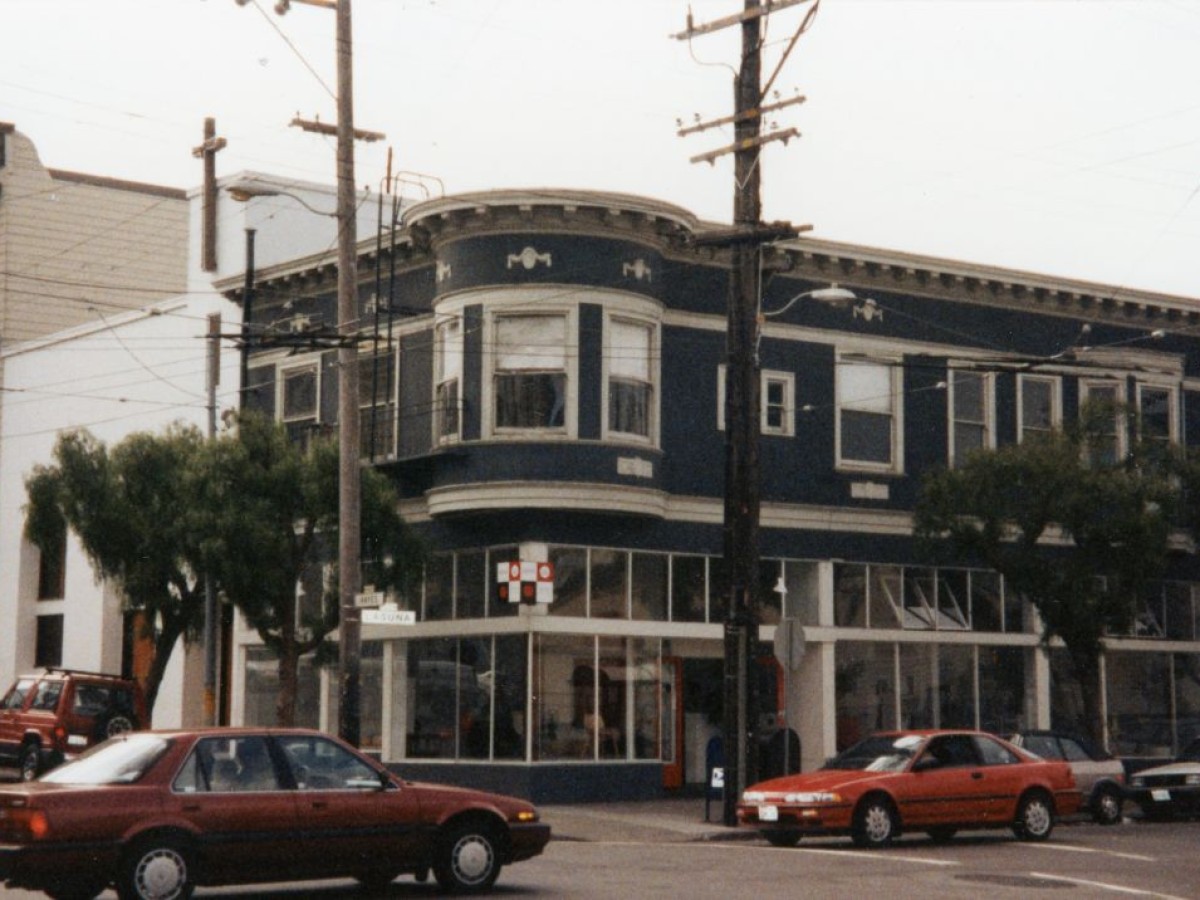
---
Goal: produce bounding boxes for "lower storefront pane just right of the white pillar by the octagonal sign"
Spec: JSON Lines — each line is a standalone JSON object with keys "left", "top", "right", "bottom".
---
{"left": 835, "top": 641, "right": 896, "bottom": 750}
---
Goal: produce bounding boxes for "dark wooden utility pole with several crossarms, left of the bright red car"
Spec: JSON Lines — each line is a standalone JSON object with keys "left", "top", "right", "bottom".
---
{"left": 674, "top": 0, "right": 805, "bottom": 826}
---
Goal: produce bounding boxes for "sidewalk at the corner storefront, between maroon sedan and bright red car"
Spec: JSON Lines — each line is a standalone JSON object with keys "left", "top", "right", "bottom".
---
{"left": 538, "top": 797, "right": 758, "bottom": 844}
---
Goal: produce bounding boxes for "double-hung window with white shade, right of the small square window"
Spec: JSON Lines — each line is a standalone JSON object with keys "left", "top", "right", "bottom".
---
{"left": 838, "top": 359, "right": 902, "bottom": 472}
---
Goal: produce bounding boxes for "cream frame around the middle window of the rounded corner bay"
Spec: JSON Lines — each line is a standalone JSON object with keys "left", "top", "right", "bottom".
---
{"left": 481, "top": 304, "right": 580, "bottom": 440}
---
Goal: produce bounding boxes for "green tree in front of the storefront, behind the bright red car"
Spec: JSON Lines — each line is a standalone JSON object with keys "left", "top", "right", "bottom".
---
{"left": 916, "top": 420, "right": 1175, "bottom": 744}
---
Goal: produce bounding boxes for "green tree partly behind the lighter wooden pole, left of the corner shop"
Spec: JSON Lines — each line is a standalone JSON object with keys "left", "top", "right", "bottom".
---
{"left": 196, "top": 413, "right": 424, "bottom": 725}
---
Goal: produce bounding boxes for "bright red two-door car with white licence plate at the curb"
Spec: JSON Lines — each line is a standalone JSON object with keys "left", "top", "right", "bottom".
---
{"left": 738, "top": 731, "right": 1081, "bottom": 847}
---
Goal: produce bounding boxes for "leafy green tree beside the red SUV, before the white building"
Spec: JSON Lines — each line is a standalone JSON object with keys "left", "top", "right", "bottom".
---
{"left": 25, "top": 425, "right": 211, "bottom": 714}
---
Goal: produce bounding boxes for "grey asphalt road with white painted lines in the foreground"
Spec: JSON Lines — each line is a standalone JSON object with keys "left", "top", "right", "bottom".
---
{"left": 5, "top": 822, "right": 1200, "bottom": 900}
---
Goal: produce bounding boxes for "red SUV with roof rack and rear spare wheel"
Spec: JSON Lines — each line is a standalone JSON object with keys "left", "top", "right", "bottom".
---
{"left": 0, "top": 668, "right": 146, "bottom": 781}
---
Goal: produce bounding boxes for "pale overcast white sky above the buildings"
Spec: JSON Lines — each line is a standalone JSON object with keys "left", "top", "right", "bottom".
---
{"left": 0, "top": 0, "right": 1200, "bottom": 302}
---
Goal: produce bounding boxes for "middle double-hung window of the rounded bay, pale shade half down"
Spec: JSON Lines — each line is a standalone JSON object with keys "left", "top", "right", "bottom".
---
{"left": 492, "top": 314, "right": 566, "bottom": 432}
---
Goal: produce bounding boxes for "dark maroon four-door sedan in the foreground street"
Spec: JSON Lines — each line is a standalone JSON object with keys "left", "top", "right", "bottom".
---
{"left": 0, "top": 728, "right": 550, "bottom": 900}
